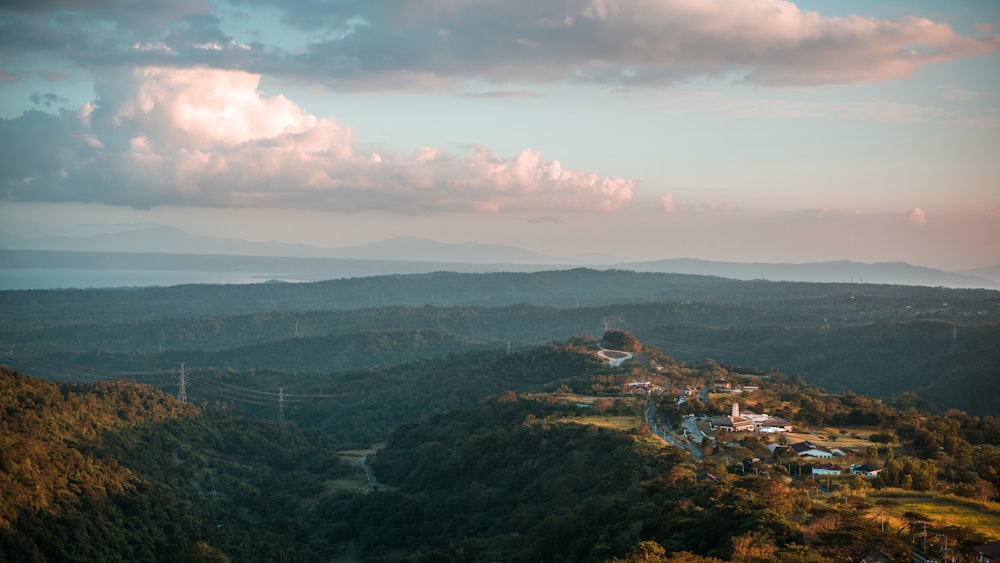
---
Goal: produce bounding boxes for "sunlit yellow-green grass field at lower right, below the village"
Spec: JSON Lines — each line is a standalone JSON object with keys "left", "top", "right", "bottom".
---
{"left": 868, "top": 489, "right": 1000, "bottom": 541}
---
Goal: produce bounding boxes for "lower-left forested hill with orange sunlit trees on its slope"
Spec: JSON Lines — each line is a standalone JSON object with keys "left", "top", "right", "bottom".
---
{"left": 0, "top": 366, "right": 357, "bottom": 562}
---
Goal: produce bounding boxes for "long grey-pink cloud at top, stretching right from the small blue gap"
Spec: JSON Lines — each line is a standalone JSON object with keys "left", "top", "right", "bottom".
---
{"left": 236, "top": 0, "right": 1000, "bottom": 89}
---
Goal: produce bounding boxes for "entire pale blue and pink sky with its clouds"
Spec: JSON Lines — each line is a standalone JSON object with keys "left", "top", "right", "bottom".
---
{"left": 0, "top": 0, "right": 1000, "bottom": 269}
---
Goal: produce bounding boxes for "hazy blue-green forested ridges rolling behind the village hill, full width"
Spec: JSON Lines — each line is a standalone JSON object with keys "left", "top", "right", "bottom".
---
{"left": 0, "top": 269, "right": 1000, "bottom": 415}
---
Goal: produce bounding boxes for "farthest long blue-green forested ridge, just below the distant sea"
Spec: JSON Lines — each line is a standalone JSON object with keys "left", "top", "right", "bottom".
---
{"left": 0, "top": 269, "right": 1000, "bottom": 325}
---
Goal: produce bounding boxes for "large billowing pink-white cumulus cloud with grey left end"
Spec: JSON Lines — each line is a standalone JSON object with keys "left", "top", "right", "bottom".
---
{"left": 0, "top": 67, "right": 635, "bottom": 213}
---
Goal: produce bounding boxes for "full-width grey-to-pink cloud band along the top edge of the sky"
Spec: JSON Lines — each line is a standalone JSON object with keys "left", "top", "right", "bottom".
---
{"left": 0, "top": 0, "right": 1000, "bottom": 90}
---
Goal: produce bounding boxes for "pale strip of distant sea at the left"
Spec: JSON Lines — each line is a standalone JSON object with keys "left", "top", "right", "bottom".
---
{"left": 0, "top": 268, "right": 301, "bottom": 290}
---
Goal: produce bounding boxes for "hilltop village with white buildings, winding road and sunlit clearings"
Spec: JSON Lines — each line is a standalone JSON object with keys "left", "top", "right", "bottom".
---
{"left": 595, "top": 331, "right": 1000, "bottom": 561}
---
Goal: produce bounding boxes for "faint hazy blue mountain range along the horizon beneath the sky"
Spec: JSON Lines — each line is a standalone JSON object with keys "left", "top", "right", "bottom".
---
{"left": 0, "top": 227, "right": 1000, "bottom": 289}
